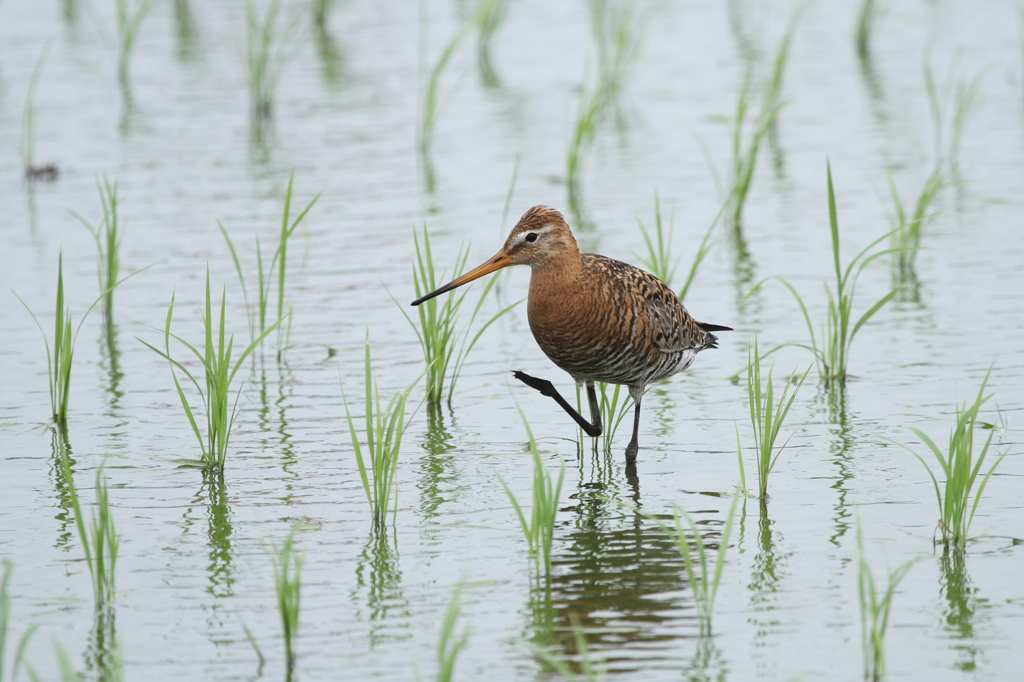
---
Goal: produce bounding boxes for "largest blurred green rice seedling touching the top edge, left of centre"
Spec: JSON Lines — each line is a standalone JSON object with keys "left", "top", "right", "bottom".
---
{"left": 246, "top": 0, "right": 297, "bottom": 118}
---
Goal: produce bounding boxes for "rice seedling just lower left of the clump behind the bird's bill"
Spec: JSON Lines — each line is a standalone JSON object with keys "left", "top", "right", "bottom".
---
{"left": 342, "top": 335, "right": 423, "bottom": 526}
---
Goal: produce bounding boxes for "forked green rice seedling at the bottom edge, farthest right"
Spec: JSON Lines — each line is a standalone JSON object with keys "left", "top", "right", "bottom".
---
{"left": 857, "top": 521, "right": 916, "bottom": 682}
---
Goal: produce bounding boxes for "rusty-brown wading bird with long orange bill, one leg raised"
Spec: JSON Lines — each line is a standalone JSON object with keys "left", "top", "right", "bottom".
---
{"left": 413, "top": 206, "right": 732, "bottom": 462}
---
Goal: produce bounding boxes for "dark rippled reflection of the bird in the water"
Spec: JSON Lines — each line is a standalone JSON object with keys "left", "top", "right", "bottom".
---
{"left": 529, "top": 454, "right": 724, "bottom": 679}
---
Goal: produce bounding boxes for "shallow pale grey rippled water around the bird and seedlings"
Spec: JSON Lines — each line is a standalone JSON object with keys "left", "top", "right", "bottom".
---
{"left": 0, "top": 0, "right": 1024, "bottom": 680}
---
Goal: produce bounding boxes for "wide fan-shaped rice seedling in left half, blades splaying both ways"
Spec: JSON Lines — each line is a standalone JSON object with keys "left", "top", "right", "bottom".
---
{"left": 139, "top": 268, "right": 281, "bottom": 476}
